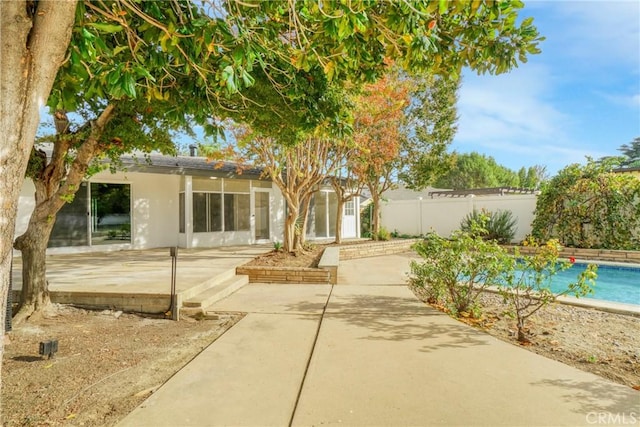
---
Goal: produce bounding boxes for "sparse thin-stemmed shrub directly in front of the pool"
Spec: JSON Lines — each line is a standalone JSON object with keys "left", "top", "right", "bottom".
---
{"left": 499, "top": 240, "right": 597, "bottom": 343}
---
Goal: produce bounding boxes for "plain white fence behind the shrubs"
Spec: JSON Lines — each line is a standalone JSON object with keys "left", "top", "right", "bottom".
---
{"left": 380, "top": 194, "right": 536, "bottom": 242}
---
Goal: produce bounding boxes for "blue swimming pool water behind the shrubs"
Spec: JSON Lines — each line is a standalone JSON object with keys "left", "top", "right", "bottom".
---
{"left": 551, "top": 263, "right": 640, "bottom": 305}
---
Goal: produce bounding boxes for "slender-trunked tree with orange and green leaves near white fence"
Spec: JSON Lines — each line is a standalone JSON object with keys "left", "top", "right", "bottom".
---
{"left": 351, "top": 71, "right": 459, "bottom": 239}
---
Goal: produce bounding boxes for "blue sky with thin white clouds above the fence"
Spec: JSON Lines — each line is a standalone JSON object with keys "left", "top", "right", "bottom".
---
{"left": 451, "top": 0, "right": 640, "bottom": 175}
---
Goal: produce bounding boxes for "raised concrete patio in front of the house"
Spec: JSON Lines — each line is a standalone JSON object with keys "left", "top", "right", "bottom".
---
{"left": 13, "top": 245, "right": 273, "bottom": 313}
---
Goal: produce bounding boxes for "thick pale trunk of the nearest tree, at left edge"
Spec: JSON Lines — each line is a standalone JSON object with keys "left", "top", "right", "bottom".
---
{"left": 0, "top": 0, "right": 76, "bottom": 418}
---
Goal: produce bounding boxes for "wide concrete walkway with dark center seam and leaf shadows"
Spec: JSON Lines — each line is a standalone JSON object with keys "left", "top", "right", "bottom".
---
{"left": 121, "top": 256, "right": 640, "bottom": 426}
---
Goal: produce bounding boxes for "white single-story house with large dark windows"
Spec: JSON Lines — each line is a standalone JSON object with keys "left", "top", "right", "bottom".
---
{"left": 16, "top": 155, "right": 360, "bottom": 253}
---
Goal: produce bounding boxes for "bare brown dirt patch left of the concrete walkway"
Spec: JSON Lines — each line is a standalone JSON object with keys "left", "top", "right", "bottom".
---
{"left": 2, "top": 305, "right": 242, "bottom": 426}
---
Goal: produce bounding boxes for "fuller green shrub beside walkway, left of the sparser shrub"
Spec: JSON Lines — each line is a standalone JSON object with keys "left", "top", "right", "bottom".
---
{"left": 411, "top": 219, "right": 508, "bottom": 317}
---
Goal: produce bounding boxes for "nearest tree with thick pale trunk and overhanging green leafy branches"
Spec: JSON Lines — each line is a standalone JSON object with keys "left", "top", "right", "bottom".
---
{"left": 0, "top": 0, "right": 541, "bottom": 412}
